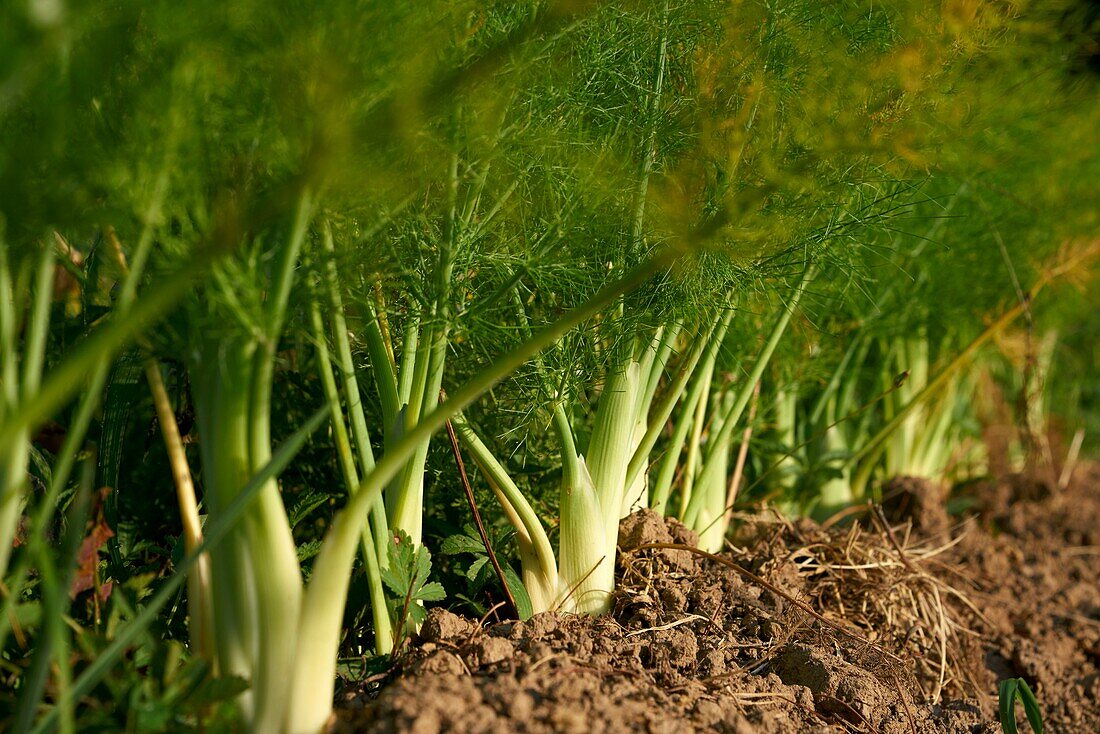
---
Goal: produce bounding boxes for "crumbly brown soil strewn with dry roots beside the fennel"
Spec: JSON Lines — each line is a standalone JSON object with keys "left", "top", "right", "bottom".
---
{"left": 333, "top": 465, "right": 1100, "bottom": 734}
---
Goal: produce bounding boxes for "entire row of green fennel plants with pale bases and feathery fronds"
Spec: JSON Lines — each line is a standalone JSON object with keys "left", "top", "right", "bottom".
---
{"left": 0, "top": 0, "right": 1098, "bottom": 732}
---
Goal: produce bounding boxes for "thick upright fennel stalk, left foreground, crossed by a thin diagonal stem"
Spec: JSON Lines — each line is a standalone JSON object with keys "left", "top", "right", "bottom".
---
{"left": 194, "top": 194, "right": 311, "bottom": 732}
